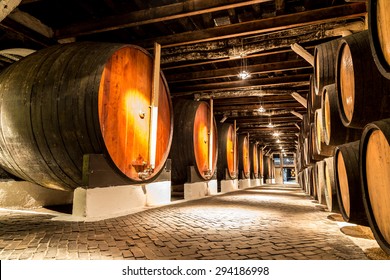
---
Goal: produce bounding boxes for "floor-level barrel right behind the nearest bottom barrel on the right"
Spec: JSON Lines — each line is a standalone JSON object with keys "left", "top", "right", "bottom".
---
{"left": 334, "top": 141, "right": 368, "bottom": 225}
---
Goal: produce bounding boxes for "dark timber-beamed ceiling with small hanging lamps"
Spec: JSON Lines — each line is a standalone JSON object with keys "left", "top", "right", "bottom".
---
{"left": 0, "top": 0, "right": 366, "bottom": 152}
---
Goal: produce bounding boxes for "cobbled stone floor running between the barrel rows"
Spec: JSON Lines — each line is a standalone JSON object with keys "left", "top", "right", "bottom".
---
{"left": 0, "top": 185, "right": 367, "bottom": 260}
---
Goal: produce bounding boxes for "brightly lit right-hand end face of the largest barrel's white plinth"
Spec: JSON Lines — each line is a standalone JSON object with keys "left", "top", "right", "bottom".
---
{"left": 145, "top": 181, "right": 171, "bottom": 206}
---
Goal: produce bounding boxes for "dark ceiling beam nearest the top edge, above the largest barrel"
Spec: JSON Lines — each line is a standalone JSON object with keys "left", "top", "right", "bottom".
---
{"left": 55, "top": 0, "right": 271, "bottom": 39}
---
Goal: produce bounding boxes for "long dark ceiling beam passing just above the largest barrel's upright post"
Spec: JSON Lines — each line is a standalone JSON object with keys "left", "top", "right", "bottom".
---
{"left": 136, "top": 3, "right": 366, "bottom": 47}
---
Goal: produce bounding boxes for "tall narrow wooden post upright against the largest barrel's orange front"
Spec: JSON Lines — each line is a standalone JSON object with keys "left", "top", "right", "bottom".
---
{"left": 149, "top": 43, "right": 161, "bottom": 170}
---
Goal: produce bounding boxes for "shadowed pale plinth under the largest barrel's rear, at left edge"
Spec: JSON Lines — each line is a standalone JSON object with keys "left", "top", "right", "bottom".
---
{"left": 0, "top": 181, "right": 73, "bottom": 209}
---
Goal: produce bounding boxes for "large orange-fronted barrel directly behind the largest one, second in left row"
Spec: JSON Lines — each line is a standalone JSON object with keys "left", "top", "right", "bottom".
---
{"left": 170, "top": 99, "right": 218, "bottom": 185}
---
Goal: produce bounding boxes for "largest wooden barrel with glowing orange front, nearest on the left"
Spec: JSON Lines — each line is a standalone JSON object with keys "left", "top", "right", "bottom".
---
{"left": 0, "top": 42, "right": 173, "bottom": 190}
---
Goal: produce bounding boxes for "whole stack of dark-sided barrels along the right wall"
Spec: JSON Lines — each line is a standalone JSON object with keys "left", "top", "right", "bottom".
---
{"left": 297, "top": 0, "right": 390, "bottom": 253}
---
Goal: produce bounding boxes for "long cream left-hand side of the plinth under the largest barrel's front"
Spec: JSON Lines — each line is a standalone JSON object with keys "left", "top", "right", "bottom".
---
{"left": 72, "top": 185, "right": 146, "bottom": 217}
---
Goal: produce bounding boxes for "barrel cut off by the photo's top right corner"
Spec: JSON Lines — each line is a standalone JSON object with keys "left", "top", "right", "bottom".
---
{"left": 368, "top": 0, "right": 390, "bottom": 79}
